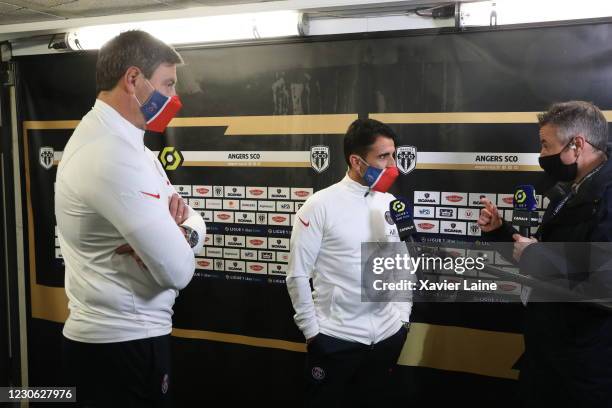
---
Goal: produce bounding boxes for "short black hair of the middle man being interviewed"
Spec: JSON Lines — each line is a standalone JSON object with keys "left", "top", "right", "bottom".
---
{"left": 344, "top": 119, "right": 397, "bottom": 166}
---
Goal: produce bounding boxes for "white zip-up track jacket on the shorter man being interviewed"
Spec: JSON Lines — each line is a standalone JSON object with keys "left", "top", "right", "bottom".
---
{"left": 287, "top": 175, "right": 412, "bottom": 344}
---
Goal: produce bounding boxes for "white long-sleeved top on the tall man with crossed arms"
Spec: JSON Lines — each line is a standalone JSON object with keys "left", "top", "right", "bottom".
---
{"left": 55, "top": 100, "right": 206, "bottom": 343}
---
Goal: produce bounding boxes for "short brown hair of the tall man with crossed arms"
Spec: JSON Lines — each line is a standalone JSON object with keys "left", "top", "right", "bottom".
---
{"left": 96, "top": 30, "right": 183, "bottom": 93}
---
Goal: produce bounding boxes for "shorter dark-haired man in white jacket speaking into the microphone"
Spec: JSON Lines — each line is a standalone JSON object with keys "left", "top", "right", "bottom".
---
{"left": 287, "top": 119, "right": 412, "bottom": 407}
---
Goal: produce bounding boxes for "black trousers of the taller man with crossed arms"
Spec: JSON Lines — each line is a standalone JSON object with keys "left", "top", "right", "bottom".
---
{"left": 62, "top": 335, "right": 171, "bottom": 408}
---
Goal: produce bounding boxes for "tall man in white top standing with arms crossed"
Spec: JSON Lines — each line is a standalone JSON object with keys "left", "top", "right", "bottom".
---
{"left": 55, "top": 31, "right": 206, "bottom": 407}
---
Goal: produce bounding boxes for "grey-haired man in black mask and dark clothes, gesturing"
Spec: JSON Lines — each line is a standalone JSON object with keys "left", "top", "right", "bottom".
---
{"left": 478, "top": 101, "right": 612, "bottom": 407}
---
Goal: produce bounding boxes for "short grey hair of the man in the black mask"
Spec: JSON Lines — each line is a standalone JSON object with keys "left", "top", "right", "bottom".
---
{"left": 538, "top": 101, "right": 608, "bottom": 152}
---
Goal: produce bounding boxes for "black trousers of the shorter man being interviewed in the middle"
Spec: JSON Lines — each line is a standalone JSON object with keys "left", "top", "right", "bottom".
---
{"left": 305, "top": 327, "right": 408, "bottom": 408}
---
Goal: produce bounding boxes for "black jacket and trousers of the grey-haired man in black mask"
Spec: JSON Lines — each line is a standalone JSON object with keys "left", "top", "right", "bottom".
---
{"left": 483, "top": 148, "right": 612, "bottom": 407}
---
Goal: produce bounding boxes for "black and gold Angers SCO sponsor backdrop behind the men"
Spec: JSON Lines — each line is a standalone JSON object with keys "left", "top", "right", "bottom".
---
{"left": 11, "top": 23, "right": 612, "bottom": 406}
